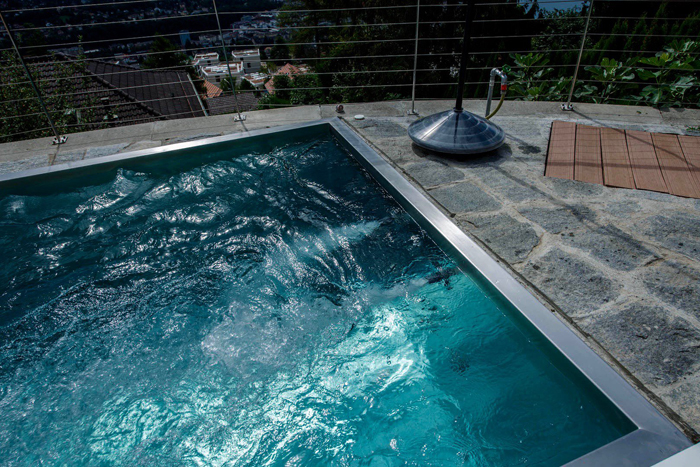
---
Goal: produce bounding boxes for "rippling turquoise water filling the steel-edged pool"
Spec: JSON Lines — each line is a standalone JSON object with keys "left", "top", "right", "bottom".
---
{"left": 0, "top": 134, "right": 632, "bottom": 466}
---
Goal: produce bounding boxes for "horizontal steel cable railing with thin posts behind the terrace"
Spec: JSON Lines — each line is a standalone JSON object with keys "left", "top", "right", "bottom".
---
{"left": 0, "top": 0, "right": 700, "bottom": 143}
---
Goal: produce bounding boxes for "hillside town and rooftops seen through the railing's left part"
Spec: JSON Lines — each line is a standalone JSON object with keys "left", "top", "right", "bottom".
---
{"left": 0, "top": 0, "right": 316, "bottom": 137}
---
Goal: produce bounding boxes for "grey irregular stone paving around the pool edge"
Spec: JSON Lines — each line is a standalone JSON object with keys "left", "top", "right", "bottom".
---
{"left": 0, "top": 101, "right": 700, "bottom": 441}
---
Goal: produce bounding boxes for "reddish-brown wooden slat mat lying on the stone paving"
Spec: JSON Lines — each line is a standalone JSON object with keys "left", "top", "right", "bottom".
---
{"left": 545, "top": 121, "right": 700, "bottom": 198}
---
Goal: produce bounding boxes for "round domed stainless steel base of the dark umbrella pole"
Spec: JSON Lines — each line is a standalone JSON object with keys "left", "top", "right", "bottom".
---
{"left": 408, "top": 109, "right": 506, "bottom": 155}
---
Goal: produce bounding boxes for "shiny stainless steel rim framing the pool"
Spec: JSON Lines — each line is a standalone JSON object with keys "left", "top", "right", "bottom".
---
{"left": 0, "top": 118, "right": 691, "bottom": 467}
